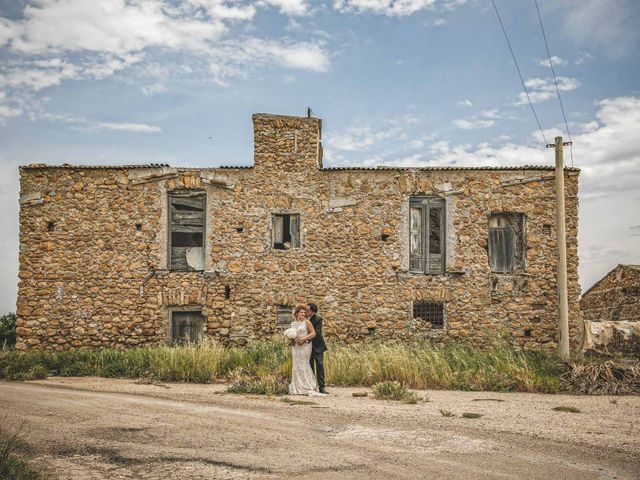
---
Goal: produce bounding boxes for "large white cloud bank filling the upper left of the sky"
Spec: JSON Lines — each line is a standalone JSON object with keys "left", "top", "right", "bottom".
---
{"left": 0, "top": 0, "right": 329, "bottom": 124}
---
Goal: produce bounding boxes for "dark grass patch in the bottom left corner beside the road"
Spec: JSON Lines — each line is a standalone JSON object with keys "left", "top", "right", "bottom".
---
{"left": 0, "top": 418, "right": 43, "bottom": 480}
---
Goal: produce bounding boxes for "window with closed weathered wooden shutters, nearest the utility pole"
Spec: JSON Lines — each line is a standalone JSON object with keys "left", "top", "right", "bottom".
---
{"left": 489, "top": 213, "right": 524, "bottom": 273}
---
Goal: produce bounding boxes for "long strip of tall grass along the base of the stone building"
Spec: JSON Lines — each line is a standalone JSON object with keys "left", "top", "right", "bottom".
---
{"left": 0, "top": 338, "right": 564, "bottom": 394}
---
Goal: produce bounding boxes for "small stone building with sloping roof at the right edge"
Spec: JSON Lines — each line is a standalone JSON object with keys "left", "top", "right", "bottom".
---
{"left": 580, "top": 265, "right": 640, "bottom": 322}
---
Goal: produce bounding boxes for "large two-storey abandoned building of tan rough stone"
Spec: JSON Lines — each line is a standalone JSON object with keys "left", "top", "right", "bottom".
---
{"left": 17, "top": 114, "right": 580, "bottom": 349}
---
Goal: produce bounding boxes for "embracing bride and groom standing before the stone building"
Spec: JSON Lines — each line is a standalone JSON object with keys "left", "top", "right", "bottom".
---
{"left": 284, "top": 303, "right": 327, "bottom": 395}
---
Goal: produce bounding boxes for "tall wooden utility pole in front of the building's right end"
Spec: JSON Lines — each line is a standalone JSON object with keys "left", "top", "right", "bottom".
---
{"left": 547, "top": 137, "right": 571, "bottom": 361}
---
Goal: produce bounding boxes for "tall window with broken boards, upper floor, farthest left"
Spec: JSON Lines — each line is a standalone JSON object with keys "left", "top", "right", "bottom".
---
{"left": 169, "top": 192, "right": 206, "bottom": 270}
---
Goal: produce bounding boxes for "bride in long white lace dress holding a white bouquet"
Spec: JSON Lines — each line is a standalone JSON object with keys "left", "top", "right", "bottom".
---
{"left": 285, "top": 305, "right": 318, "bottom": 395}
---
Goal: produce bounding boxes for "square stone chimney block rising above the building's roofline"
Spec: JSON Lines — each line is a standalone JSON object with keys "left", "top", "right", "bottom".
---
{"left": 253, "top": 113, "right": 322, "bottom": 172}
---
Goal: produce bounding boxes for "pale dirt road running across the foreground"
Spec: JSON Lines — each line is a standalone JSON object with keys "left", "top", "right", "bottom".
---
{"left": 0, "top": 378, "right": 640, "bottom": 480}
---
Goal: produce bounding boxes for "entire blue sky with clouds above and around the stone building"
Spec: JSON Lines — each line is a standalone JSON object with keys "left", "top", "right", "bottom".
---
{"left": 0, "top": 0, "right": 640, "bottom": 311}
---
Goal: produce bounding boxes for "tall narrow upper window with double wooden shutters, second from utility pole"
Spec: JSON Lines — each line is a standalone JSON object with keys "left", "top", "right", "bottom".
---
{"left": 409, "top": 197, "right": 445, "bottom": 274}
